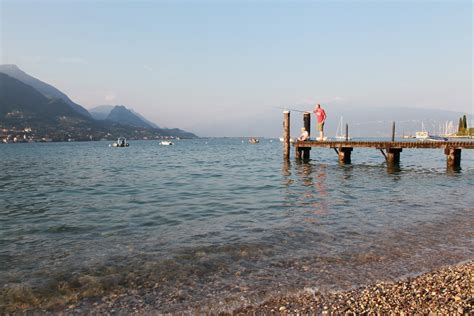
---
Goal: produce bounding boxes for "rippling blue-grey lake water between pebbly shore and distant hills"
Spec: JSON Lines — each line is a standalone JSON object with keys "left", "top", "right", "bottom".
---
{"left": 0, "top": 138, "right": 474, "bottom": 312}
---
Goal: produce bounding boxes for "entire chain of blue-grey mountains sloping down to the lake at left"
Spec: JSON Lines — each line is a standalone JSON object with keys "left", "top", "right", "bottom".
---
{"left": 0, "top": 65, "right": 197, "bottom": 140}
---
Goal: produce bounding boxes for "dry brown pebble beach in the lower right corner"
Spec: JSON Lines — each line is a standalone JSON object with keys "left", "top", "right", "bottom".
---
{"left": 235, "top": 261, "right": 474, "bottom": 315}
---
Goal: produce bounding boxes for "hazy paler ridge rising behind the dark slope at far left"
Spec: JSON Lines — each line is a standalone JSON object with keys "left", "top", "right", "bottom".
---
{"left": 0, "top": 65, "right": 91, "bottom": 118}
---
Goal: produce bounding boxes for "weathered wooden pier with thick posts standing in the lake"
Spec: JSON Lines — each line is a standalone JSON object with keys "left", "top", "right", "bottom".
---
{"left": 283, "top": 111, "right": 474, "bottom": 168}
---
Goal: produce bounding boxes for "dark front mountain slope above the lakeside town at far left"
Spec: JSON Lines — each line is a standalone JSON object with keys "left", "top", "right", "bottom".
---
{"left": 0, "top": 73, "right": 91, "bottom": 125}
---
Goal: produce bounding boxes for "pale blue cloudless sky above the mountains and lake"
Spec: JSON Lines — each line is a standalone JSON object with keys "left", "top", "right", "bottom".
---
{"left": 0, "top": 0, "right": 474, "bottom": 136}
